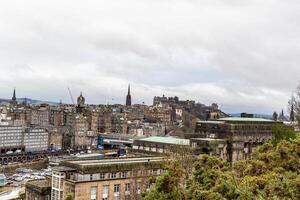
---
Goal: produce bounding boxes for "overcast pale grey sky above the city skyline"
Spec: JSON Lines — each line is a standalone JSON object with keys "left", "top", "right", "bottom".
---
{"left": 0, "top": 0, "right": 300, "bottom": 113}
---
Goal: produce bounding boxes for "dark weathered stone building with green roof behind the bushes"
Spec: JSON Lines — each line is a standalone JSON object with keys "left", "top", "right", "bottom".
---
{"left": 190, "top": 117, "right": 278, "bottom": 162}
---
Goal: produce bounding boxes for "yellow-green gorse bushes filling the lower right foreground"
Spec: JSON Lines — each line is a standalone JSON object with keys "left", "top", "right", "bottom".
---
{"left": 144, "top": 134, "right": 300, "bottom": 200}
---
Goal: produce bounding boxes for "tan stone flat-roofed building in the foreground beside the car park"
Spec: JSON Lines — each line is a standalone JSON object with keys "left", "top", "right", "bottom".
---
{"left": 51, "top": 157, "right": 163, "bottom": 200}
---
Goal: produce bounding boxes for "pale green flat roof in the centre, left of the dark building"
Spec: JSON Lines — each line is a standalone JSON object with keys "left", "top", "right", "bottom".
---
{"left": 137, "top": 136, "right": 190, "bottom": 145}
